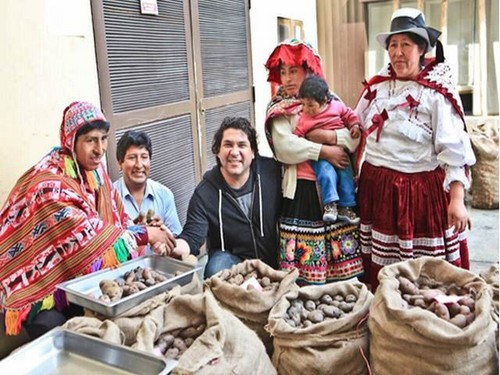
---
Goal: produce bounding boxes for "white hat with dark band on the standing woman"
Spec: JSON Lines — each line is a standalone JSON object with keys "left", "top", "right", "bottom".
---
{"left": 376, "top": 8, "right": 441, "bottom": 53}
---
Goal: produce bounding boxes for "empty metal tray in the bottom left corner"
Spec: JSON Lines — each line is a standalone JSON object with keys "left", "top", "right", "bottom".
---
{"left": 0, "top": 328, "right": 177, "bottom": 375}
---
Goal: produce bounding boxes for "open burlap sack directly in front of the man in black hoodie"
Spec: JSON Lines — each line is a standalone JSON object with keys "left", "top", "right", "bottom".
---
{"left": 204, "top": 259, "right": 299, "bottom": 354}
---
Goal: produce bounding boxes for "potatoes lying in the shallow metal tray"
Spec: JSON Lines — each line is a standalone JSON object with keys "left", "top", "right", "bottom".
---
{"left": 99, "top": 266, "right": 167, "bottom": 302}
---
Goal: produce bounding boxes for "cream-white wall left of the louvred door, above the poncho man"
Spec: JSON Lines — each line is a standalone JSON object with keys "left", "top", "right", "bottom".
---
{"left": 0, "top": 0, "right": 100, "bottom": 206}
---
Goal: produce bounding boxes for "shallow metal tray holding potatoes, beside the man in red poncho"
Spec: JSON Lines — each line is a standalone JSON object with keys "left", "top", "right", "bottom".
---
{"left": 57, "top": 255, "right": 200, "bottom": 317}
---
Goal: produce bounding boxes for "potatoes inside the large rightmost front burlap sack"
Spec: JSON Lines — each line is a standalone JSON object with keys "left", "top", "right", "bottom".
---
{"left": 397, "top": 275, "right": 476, "bottom": 328}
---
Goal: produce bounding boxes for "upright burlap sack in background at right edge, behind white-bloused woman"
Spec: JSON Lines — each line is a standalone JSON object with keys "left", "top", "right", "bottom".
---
{"left": 468, "top": 119, "right": 498, "bottom": 209}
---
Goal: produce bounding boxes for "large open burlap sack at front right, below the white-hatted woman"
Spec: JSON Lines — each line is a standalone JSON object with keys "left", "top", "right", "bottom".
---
{"left": 368, "top": 257, "right": 498, "bottom": 375}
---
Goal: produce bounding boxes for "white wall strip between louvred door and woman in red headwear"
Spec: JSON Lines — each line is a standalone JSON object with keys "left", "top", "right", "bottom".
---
{"left": 250, "top": 0, "right": 318, "bottom": 156}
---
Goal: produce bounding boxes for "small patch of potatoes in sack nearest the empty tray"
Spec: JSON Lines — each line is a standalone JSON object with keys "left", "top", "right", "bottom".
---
{"left": 153, "top": 323, "right": 206, "bottom": 359}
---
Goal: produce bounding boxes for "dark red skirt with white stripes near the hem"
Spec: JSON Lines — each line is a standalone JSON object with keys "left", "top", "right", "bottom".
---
{"left": 358, "top": 162, "right": 470, "bottom": 291}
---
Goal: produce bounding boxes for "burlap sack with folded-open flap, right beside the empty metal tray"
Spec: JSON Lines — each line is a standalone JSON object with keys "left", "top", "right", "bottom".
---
{"left": 163, "top": 290, "right": 276, "bottom": 375}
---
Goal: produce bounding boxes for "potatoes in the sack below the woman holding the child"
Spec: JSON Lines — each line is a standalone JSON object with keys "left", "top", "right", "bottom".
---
{"left": 283, "top": 294, "right": 357, "bottom": 328}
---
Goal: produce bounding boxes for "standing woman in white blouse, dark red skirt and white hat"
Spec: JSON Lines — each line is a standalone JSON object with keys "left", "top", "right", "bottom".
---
{"left": 356, "top": 8, "right": 475, "bottom": 291}
